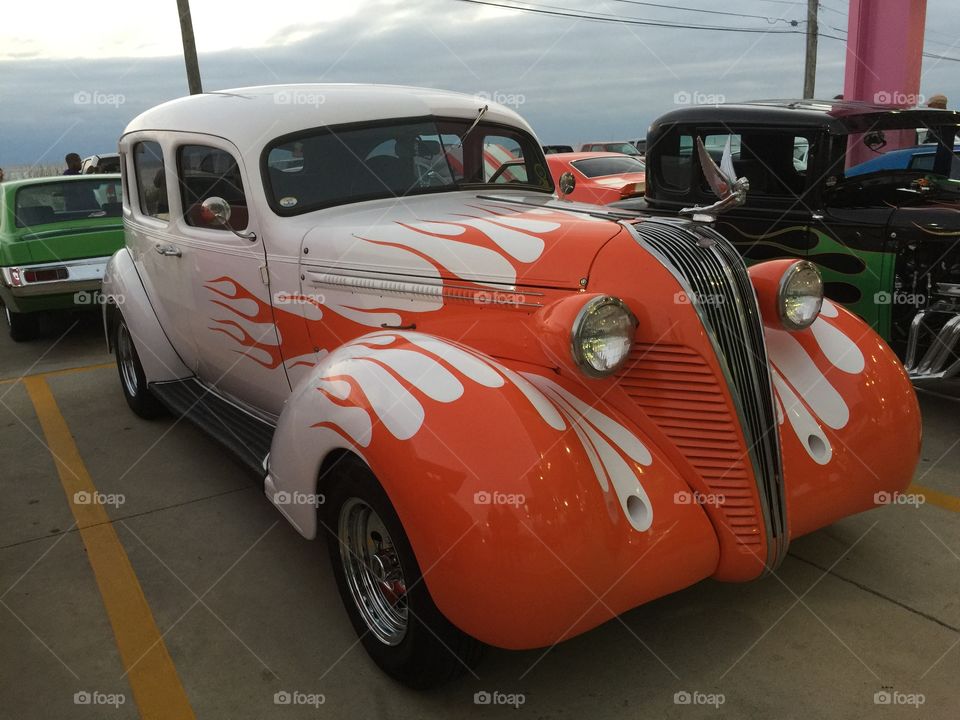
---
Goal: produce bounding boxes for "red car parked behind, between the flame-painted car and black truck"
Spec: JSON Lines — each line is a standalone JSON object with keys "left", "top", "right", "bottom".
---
{"left": 546, "top": 152, "right": 647, "bottom": 205}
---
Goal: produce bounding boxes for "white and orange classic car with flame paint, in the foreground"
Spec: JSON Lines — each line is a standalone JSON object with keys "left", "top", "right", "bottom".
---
{"left": 103, "top": 85, "right": 920, "bottom": 687}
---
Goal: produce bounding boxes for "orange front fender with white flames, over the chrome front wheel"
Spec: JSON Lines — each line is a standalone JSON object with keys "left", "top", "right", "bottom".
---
{"left": 266, "top": 331, "right": 719, "bottom": 648}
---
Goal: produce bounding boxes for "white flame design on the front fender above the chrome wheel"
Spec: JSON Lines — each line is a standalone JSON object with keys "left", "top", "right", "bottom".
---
{"left": 315, "top": 332, "right": 653, "bottom": 532}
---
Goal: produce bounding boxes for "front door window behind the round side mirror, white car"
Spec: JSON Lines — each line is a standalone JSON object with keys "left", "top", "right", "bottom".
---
{"left": 177, "top": 145, "right": 248, "bottom": 231}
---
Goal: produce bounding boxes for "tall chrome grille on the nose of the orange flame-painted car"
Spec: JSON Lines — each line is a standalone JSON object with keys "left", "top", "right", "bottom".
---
{"left": 627, "top": 219, "right": 789, "bottom": 570}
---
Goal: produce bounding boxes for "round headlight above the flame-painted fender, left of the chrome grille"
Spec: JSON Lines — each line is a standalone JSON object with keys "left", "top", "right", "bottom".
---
{"left": 571, "top": 296, "right": 637, "bottom": 377}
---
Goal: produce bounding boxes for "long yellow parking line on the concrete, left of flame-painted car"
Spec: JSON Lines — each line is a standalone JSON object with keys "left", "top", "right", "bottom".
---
{"left": 23, "top": 375, "right": 195, "bottom": 719}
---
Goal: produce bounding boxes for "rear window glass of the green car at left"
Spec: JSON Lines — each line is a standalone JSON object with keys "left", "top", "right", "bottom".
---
{"left": 15, "top": 178, "right": 122, "bottom": 227}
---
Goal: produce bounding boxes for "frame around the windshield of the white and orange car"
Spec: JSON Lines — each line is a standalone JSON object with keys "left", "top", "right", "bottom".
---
{"left": 260, "top": 115, "right": 555, "bottom": 217}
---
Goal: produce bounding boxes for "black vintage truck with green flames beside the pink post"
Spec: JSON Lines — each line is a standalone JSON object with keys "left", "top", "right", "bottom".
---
{"left": 613, "top": 100, "right": 960, "bottom": 380}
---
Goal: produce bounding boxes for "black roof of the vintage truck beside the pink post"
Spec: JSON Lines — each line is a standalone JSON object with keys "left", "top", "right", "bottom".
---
{"left": 651, "top": 99, "right": 960, "bottom": 134}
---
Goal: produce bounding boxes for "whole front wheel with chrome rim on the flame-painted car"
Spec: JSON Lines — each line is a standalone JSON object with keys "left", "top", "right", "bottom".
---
{"left": 323, "top": 456, "right": 483, "bottom": 689}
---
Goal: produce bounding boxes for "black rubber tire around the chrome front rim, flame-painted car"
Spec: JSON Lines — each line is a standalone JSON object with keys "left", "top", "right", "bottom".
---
{"left": 320, "top": 455, "right": 484, "bottom": 690}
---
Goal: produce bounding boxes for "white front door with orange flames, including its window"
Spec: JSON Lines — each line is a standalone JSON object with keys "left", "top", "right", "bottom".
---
{"left": 173, "top": 134, "right": 290, "bottom": 416}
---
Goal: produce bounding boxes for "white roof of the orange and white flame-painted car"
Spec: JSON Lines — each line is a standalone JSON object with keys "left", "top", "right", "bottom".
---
{"left": 121, "top": 83, "right": 533, "bottom": 155}
